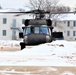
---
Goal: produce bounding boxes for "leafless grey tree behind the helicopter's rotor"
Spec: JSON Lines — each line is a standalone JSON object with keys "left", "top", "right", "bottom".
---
{"left": 27, "top": 0, "right": 70, "bottom": 18}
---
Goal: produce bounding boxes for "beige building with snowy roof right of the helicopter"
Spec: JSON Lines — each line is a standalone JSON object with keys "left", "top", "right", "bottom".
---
{"left": 53, "top": 13, "right": 76, "bottom": 41}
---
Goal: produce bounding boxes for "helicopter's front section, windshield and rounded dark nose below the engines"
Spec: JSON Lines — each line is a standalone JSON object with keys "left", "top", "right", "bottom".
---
{"left": 23, "top": 25, "right": 51, "bottom": 45}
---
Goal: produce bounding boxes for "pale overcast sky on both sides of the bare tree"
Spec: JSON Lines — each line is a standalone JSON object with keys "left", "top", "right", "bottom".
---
{"left": 0, "top": 0, "right": 76, "bottom": 9}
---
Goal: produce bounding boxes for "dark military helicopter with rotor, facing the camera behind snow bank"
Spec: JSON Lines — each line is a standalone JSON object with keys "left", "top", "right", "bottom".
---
{"left": 0, "top": 10, "right": 63, "bottom": 50}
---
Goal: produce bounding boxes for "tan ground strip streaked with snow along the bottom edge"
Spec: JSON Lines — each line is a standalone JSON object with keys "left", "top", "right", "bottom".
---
{"left": 0, "top": 66, "right": 76, "bottom": 75}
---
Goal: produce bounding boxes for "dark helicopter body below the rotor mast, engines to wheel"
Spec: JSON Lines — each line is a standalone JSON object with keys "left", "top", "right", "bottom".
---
{"left": 19, "top": 19, "right": 53, "bottom": 49}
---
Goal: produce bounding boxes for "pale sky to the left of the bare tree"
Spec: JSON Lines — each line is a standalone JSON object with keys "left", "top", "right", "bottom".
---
{"left": 0, "top": 0, "right": 28, "bottom": 9}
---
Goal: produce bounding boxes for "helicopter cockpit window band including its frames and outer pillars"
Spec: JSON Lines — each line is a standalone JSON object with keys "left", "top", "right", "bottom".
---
{"left": 24, "top": 25, "right": 51, "bottom": 35}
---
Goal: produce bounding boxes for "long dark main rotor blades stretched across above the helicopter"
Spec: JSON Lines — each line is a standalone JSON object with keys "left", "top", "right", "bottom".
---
{"left": 0, "top": 10, "right": 76, "bottom": 14}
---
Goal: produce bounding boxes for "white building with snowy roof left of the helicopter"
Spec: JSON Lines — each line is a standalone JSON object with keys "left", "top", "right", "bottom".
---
{"left": 0, "top": 9, "right": 32, "bottom": 40}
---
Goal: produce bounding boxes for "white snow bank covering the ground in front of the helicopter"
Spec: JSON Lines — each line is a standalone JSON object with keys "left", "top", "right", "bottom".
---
{"left": 0, "top": 40, "right": 76, "bottom": 66}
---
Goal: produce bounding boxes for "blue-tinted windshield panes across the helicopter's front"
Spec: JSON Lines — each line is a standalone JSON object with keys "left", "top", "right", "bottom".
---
{"left": 25, "top": 26, "right": 49, "bottom": 34}
